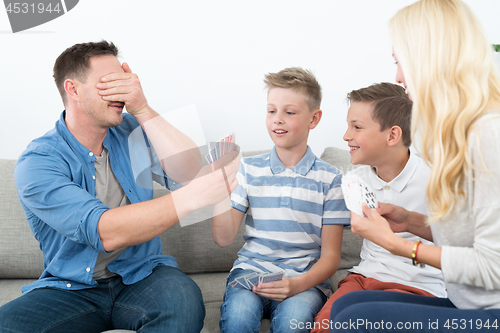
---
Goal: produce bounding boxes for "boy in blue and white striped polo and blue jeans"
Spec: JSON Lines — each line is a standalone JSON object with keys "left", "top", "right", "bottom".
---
{"left": 212, "top": 68, "right": 350, "bottom": 333}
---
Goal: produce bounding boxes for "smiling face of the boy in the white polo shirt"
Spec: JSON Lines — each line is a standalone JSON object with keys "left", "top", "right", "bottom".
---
{"left": 344, "top": 102, "right": 390, "bottom": 166}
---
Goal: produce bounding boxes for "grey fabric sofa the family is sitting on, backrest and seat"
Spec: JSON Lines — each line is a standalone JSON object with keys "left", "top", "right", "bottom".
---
{"left": 0, "top": 148, "right": 362, "bottom": 333}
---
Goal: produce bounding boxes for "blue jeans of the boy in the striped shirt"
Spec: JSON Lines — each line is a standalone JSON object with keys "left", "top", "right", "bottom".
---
{"left": 219, "top": 269, "right": 326, "bottom": 333}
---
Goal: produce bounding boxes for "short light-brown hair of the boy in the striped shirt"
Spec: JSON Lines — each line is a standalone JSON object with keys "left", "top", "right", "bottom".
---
{"left": 264, "top": 67, "right": 321, "bottom": 111}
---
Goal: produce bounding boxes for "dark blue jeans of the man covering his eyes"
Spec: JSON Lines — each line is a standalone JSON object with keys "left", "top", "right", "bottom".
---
{"left": 0, "top": 266, "right": 205, "bottom": 333}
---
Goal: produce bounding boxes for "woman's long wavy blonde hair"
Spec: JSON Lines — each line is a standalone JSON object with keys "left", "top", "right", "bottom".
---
{"left": 390, "top": 0, "right": 500, "bottom": 222}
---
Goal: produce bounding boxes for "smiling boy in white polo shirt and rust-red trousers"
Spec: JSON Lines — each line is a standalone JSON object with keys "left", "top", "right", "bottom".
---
{"left": 311, "top": 83, "right": 446, "bottom": 333}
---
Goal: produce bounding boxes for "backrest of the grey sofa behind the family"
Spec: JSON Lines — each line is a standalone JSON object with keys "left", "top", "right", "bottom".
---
{"left": 0, "top": 148, "right": 362, "bottom": 279}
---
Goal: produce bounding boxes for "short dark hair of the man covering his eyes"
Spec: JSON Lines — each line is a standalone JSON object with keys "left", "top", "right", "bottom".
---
{"left": 54, "top": 40, "right": 118, "bottom": 103}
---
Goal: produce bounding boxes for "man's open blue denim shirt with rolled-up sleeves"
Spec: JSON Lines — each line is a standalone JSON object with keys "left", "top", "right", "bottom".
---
{"left": 15, "top": 112, "right": 177, "bottom": 293}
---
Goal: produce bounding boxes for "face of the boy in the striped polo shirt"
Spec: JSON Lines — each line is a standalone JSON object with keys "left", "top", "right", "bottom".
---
{"left": 266, "top": 87, "right": 321, "bottom": 152}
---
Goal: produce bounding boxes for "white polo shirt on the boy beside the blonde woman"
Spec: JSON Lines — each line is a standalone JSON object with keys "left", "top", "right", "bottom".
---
{"left": 349, "top": 150, "right": 446, "bottom": 297}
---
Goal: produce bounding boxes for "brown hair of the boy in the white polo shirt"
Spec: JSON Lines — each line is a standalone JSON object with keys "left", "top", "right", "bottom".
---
{"left": 347, "top": 82, "right": 413, "bottom": 147}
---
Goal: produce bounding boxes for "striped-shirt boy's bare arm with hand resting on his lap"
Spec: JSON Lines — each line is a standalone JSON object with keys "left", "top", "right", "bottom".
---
{"left": 253, "top": 225, "right": 343, "bottom": 301}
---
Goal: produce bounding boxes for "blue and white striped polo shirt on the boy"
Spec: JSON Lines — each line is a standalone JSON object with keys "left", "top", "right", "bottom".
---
{"left": 231, "top": 147, "right": 350, "bottom": 291}
